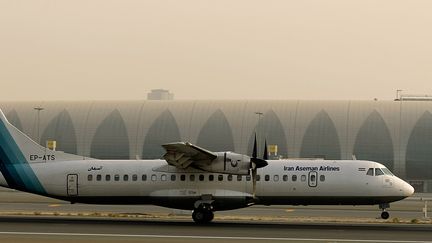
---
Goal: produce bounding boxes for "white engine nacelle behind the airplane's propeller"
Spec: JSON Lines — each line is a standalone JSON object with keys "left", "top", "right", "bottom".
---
{"left": 195, "top": 152, "right": 251, "bottom": 175}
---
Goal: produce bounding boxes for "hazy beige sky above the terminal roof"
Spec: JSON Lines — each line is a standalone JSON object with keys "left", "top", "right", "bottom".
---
{"left": 0, "top": 0, "right": 432, "bottom": 100}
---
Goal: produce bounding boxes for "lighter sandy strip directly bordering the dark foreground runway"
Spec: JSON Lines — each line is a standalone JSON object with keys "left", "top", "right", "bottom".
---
{"left": 0, "top": 202, "right": 423, "bottom": 222}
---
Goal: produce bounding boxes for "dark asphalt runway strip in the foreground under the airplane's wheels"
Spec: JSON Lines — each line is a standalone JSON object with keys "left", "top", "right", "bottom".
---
{"left": 0, "top": 217, "right": 432, "bottom": 242}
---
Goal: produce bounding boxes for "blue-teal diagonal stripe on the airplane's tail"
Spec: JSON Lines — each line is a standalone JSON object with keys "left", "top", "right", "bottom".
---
{"left": 0, "top": 118, "right": 46, "bottom": 195}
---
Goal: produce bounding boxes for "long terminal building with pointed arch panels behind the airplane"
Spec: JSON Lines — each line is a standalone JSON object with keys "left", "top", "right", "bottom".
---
{"left": 0, "top": 100, "right": 432, "bottom": 192}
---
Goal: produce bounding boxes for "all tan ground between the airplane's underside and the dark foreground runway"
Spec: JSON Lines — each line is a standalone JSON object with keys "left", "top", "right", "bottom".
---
{"left": 0, "top": 189, "right": 432, "bottom": 222}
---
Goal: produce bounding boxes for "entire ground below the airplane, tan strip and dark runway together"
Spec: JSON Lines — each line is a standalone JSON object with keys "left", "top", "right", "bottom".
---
{"left": 0, "top": 191, "right": 432, "bottom": 243}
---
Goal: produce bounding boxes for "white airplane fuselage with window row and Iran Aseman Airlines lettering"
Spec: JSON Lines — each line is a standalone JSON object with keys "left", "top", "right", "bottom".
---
{"left": 0, "top": 160, "right": 413, "bottom": 210}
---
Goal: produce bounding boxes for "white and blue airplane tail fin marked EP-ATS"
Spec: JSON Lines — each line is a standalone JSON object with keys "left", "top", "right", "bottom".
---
{"left": 0, "top": 109, "right": 88, "bottom": 195}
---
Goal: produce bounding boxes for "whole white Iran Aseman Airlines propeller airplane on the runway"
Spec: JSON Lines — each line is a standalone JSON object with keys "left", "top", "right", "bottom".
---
{"left": 0, "top": 109, "right": 414, "bottom": 223}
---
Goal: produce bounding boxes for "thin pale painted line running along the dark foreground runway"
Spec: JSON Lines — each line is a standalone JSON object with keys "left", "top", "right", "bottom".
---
{"left": 0, "top": 231, "right": 432, "bottom": 243}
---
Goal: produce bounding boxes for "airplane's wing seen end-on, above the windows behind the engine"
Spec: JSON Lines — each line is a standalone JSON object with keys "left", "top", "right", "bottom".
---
{"left": 162, "top": 142, "right": 217, "bottom": 169}
